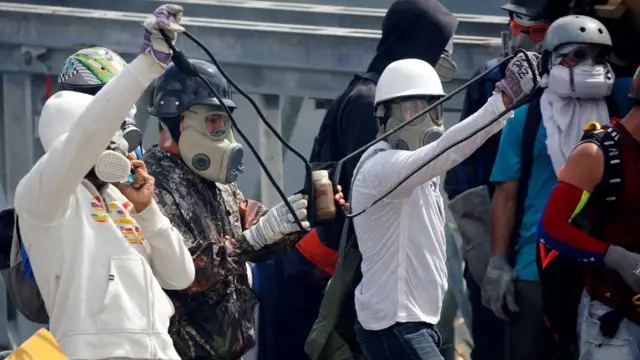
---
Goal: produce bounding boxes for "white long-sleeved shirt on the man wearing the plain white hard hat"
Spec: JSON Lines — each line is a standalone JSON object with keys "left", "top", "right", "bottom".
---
{"left": 351, "top": 95, "right": 513, "bottom": 330}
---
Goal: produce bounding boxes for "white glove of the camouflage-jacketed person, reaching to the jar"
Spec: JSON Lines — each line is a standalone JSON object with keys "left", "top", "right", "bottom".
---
{"left": 243, "top": 194, "right": 310, "bottom": 250}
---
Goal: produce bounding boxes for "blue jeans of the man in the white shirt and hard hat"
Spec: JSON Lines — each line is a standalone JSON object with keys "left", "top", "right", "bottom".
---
{"left": 356, "top": 322, "right": 443, "bottom": 360}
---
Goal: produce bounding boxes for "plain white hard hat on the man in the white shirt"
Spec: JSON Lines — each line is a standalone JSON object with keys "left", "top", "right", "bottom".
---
{"left": 374, "top": 59, "right": 445, "bottom": 108}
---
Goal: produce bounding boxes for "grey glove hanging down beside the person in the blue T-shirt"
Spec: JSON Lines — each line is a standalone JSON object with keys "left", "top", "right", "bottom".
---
{"left": 482, "top": 255, "right": 520, "bottom": 320}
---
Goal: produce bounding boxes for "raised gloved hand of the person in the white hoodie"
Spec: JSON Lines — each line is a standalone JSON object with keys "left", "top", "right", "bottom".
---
{"left": 140, "top": 4, "right": 184, "bottom": 67}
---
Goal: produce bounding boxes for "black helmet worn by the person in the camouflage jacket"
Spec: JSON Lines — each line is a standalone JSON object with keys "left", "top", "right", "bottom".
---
{"left": 148, "top": 59, "right": 237, "bottom": 141}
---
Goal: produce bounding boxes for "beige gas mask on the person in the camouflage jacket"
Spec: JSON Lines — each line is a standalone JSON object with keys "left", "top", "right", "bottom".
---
{"left": 178, "top": 105, "right": 244, "bottom": 184}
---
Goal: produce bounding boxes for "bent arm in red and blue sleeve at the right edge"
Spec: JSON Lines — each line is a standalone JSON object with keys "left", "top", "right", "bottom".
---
{"left": 538, "top": 143, "right": 608, "bottom": 262}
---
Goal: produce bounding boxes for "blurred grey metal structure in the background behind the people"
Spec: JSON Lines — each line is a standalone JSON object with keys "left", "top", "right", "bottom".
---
{"left": 0, "top": 0, "right": 508, "bottom": 354}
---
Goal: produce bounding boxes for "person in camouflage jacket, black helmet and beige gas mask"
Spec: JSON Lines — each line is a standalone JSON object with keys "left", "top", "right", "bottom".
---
{"left": 144, "top": 60, "right": 318, "bottom": 360}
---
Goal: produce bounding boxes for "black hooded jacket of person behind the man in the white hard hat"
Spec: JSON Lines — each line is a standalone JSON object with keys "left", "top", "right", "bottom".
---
{"left": 310, "top": 0, "right": 458, "bottom": 250}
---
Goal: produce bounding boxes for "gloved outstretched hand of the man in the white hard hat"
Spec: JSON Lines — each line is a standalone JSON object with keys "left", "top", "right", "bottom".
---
{"left": 496, "top": 52, "right": 540, "bottom": 104}
